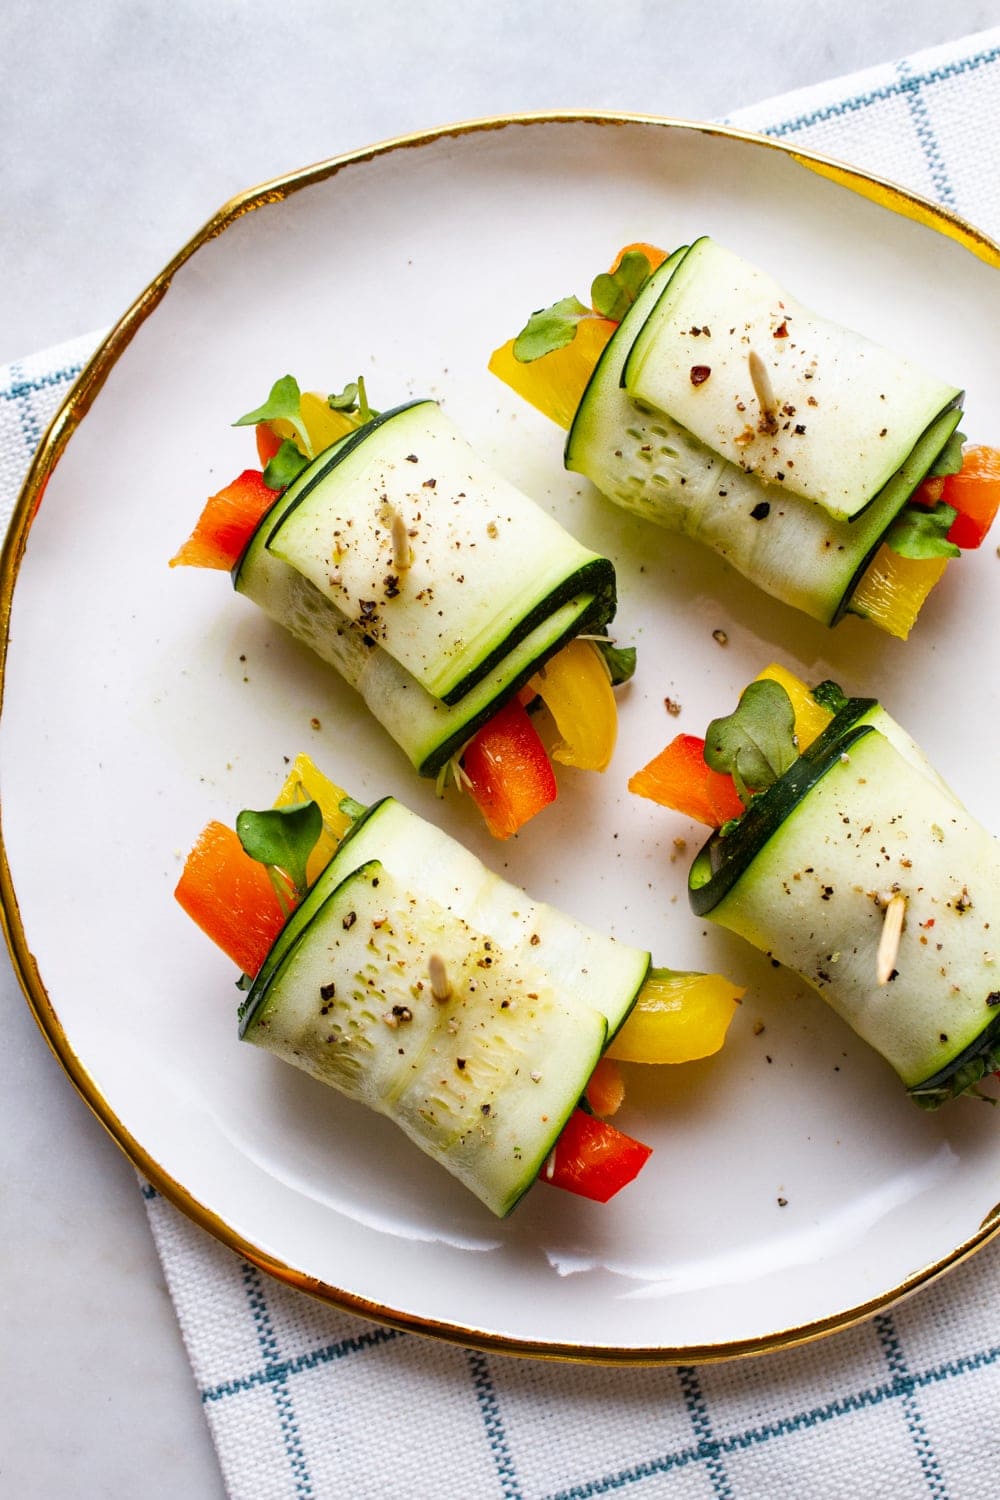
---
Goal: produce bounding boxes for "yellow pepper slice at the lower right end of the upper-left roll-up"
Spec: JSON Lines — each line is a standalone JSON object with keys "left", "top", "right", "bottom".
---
{"left": 528, "top": 638, "right": 618, "bottom": 771}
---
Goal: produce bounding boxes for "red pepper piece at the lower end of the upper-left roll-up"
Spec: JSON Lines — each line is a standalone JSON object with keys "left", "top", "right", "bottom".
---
{"left": 462, "top": 698, "right": 556, "bottom": 839}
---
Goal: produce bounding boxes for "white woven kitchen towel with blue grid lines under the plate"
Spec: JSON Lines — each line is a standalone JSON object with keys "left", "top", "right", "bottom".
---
{"left": 7, "top": 29, "right": 1000, "bottom": 1500}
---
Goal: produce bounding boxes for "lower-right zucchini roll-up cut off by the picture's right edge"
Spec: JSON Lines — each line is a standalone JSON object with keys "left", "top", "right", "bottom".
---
{"left": 630, "top": 668, "right": 1000, "bottom": 1107}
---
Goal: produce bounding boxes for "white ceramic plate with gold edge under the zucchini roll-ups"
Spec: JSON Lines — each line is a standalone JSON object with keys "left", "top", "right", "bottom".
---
{"left": 0, "top": 117, "right": 1000, "bottom": 1361}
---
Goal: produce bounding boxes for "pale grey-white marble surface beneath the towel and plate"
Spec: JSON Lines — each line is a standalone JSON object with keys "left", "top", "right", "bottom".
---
{"left": 0, "top": 0, "right": 1000, "bottom": 1500}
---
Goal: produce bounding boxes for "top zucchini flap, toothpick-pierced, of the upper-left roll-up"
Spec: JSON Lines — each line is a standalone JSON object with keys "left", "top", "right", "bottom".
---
{"left": 267, "top": 401, "right": 613, "bottom": 704}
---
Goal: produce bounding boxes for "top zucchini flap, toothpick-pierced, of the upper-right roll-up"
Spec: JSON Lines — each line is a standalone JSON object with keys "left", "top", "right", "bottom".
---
{"left": 624, "top": 237, "right": 961, "bottom": 521}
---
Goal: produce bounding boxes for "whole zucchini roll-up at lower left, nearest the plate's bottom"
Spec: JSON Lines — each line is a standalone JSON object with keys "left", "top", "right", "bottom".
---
{"left": 177, "top": 758, "right": 741, "bottom": 1215}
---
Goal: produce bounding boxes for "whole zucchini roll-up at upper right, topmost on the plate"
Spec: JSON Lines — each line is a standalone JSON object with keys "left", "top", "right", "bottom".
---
{"left": 490, "top": 237, "right": 1000, "bottom": 638}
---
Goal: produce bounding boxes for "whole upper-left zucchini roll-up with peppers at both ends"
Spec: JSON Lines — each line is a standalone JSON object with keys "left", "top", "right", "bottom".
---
{"left": 167, "top": 378, "right": 630, "bottom": 836}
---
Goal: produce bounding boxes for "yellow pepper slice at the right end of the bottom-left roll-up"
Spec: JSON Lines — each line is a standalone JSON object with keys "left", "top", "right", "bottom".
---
{"left": 606, "top": 969, "right": 745, "bottom": 1062}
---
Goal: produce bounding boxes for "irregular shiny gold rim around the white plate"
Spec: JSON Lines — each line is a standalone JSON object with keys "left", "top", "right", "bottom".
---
{"left": 0, "top": 111, "right": 1000, "bottom": 1365}
